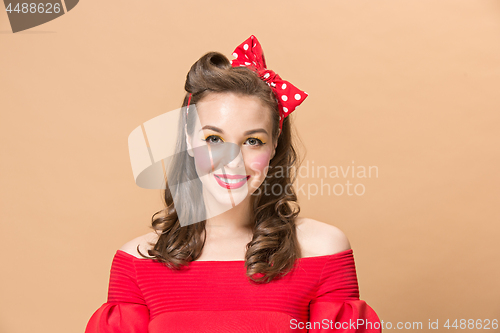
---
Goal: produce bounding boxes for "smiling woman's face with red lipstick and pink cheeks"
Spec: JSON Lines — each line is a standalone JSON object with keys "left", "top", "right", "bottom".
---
{"left": 187, "top": 93, "right": 276, "bottom": 208}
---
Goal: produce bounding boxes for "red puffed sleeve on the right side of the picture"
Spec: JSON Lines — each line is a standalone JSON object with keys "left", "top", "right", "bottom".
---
{"left": 308, "top": 249, "right": 382, "bottom": 333}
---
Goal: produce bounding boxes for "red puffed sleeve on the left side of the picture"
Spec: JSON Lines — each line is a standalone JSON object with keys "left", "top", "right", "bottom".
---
{"left": 85, "top": 251, "right": 149, "bottom": 333}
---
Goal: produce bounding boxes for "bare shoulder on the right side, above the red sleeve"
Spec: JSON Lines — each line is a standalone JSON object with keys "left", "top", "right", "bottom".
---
{"left": 296, "top": 217, "right": 351, "bottom": 257}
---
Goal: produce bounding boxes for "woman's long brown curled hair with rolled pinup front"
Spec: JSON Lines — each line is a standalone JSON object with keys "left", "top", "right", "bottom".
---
{"left": 137, "top": 52, "right": 302, "bottom": 283}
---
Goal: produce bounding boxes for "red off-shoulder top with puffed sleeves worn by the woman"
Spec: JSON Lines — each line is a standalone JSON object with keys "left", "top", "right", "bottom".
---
{"left": 85, "top": 249, "right": 382, "bottom": 333}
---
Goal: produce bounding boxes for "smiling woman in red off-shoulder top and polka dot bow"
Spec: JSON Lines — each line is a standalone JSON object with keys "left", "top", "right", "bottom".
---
{"left": 85, "top": 35, "right": 381, "bottom": 333}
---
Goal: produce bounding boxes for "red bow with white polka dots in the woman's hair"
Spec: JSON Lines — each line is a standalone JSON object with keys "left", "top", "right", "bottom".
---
{"left": 231, "top": 35, "right": 308, "bottom": 132}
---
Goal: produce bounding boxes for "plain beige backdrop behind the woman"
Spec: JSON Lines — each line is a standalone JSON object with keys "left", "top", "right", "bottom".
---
{"left": 0, "top": 0, "right": 500, "bottom": 333}
